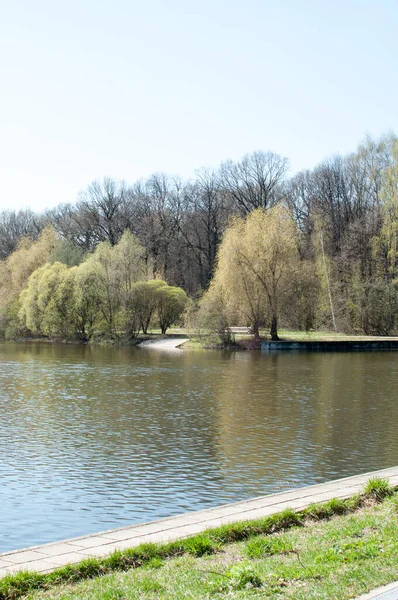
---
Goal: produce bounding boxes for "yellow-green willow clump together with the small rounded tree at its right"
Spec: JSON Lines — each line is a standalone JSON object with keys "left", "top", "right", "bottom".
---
{"left": 18, "top": 232, "right": 188, "bottom": 339}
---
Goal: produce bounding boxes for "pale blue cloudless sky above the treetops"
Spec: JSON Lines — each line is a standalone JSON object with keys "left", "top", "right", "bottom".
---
{"left": 0, "top": 0, "right": 398, "bottom": 211}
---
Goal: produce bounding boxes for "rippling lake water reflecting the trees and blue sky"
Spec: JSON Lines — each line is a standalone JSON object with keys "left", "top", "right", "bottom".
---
{"left": 0, "top": 343, "right": 398, "bottom": 552}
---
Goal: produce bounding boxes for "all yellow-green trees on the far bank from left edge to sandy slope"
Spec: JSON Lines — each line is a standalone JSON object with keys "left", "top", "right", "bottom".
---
{"left": 0, "top": 227, "right": 188, "bottom": 341}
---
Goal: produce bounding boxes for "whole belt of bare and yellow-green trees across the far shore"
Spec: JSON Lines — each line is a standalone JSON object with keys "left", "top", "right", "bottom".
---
{"left": 0, "top": 134, "right": 398, "bottom": 339}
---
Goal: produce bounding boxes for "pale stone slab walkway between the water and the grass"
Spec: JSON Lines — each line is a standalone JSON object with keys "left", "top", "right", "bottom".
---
{"left": 0, "top": 467, "right": 398, "bottom": 577}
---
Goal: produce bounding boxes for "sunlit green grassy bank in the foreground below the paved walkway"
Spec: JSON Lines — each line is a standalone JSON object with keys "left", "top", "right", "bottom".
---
{"left": 0, "top": 480, "right": 398, "bottom": 600}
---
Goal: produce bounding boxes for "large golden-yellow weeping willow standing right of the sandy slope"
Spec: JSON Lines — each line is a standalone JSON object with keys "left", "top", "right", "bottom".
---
{"left": 214, "top": 205, "right": 299, "bottom": 340}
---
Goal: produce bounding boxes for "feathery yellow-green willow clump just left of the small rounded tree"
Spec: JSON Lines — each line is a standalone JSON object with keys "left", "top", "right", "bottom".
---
{"left": 18, "top": 232, "right": 146, "bottom": 339}
